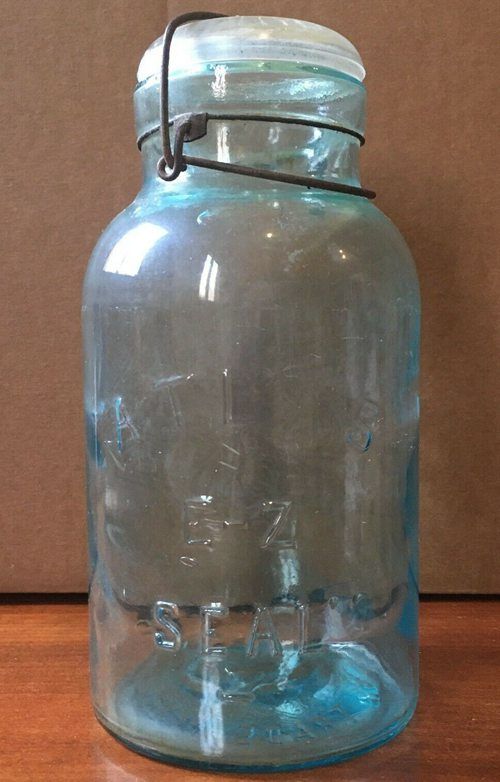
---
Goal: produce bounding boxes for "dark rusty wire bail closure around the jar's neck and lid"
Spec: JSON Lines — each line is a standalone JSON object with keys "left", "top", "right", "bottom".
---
{"left": 152, "top": 11, "right": 375, "bottom": 199}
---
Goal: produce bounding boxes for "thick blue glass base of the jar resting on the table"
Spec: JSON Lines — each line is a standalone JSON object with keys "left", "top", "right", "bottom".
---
{"left": 96, "top": 644, "right": 416, "bottom": 773}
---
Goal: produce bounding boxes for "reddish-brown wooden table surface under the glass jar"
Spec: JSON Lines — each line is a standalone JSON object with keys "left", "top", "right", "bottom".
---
{"left": 0, "top": 600, "right": 500, "bottom": 782}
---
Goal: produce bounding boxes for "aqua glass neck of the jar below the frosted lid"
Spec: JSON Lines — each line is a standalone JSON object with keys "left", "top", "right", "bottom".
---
{"left": 135, "top": 63, "right": 365, "bottom": 188}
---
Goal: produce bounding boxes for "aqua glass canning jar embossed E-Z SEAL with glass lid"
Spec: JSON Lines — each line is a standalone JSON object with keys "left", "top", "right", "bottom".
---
{"left": 83, "top": 17, "right": 419, "bottom": 771}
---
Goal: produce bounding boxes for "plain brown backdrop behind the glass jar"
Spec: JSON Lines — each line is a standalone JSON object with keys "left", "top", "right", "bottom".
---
{"left": 0, "top": 0, "right": 500, "bottom": 592}
